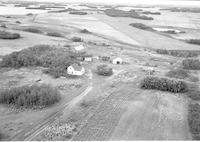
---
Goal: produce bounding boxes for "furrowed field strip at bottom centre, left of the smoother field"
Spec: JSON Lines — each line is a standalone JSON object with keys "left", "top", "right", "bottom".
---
{"left": 72, "top": 85, "right": 140, "bottom": 141}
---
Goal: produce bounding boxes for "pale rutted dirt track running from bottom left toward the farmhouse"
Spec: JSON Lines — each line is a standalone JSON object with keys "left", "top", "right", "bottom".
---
{"left": 10, "top": 86, "right": 92, "bottom": 141}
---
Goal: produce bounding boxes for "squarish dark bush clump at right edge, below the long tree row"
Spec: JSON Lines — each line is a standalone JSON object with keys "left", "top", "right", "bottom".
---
{"left": 182, "top": 59, "right": 200, "bottom": 70}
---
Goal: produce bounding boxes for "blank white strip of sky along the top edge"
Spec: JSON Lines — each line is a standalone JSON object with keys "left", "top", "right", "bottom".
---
{"left": 4, "top": 0, "right": 200, "bottom": 7}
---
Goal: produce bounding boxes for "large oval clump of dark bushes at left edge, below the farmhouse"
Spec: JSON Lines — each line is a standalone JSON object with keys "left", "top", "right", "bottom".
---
{"left": 0, "top": 84, "right": 61, "bottom": 108}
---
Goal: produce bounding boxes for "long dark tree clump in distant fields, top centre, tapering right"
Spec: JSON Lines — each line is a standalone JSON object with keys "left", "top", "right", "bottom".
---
{"left": 104, "top": 8, "right": 153, "bottom": 20}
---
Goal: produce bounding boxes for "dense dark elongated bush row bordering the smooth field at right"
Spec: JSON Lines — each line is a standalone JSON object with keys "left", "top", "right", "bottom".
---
{"left": 140, "top": 76, "right": 188, "bottom": 93}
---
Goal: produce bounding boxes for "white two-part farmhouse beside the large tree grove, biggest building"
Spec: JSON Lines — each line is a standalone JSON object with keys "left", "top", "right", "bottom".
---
{"left": 67, "top": 63, "right": 85, "bottom": 76}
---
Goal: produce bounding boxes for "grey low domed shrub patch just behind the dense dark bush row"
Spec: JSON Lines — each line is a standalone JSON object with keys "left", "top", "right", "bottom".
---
{"left": 166, "top": 68, "right": 189, "bottom": 79}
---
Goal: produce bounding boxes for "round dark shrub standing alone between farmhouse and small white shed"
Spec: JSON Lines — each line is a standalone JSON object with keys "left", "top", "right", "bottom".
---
{"left": 97, "top": 65, "right": 113, "bottom": 76}
